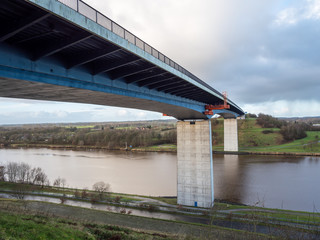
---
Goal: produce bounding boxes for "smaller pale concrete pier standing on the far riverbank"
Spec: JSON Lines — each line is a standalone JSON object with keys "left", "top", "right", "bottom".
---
{"left": 224, "top": 119, "right": 239, "bottom": 152}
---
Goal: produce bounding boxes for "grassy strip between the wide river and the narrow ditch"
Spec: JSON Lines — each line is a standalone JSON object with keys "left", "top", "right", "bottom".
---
{"left": 0, "top": 181, "right": 320, "bottom": 224}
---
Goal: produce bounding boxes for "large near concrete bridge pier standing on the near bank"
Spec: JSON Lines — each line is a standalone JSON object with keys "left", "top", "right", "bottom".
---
{"left": 177, "top": 120, "right": 214, "bottom": 208}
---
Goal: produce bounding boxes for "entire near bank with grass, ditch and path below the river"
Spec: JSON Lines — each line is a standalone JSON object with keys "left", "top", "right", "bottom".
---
{"left": 0, "top": 181, "right": 320, "bottom": 239}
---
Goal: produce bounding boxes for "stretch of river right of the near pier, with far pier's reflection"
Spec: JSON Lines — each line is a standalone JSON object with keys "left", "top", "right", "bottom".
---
{"left": 214, "top": 155, "right": 320, "bottom": 211}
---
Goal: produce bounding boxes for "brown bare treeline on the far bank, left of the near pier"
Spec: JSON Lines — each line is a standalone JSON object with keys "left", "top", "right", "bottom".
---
{"left": 0, "top": 124, "right": 177, "bottom": 149}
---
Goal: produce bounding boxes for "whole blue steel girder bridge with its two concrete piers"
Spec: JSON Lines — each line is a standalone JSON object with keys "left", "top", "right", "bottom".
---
{"left": 0, "top": 0, "right": 244, "bottom": 207}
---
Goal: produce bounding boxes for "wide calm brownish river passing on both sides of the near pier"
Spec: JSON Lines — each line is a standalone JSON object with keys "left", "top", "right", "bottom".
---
{"left": 0, "top": 149, "right": 320, "bottom": 212}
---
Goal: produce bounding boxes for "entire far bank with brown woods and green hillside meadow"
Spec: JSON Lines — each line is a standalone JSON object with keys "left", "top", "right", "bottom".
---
{"left": 0, "top": 114, "right": 320, "bottom": 156}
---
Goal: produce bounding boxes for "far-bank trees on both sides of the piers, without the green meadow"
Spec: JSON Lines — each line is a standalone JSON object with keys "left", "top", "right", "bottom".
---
{"left": 0, "top": 113, "right": 320, "bottom": 149}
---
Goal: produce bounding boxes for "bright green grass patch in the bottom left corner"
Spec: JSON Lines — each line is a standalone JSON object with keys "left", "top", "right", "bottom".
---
{"left": 0, "top": 207, "right": 176, "bottom": 240}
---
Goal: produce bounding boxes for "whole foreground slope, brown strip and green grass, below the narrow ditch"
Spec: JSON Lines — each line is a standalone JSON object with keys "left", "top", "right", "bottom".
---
{"left": 0, "top": 199, "right": 269, "bottom": 240}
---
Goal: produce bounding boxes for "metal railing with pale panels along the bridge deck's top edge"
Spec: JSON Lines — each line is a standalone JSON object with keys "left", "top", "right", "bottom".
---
{"left": 58, "top": 0, "right": 223, "bottom": 99}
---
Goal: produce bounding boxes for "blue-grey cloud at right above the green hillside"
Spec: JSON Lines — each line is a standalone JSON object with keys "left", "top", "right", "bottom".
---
{"left": 204, "top": 3, "right": 320, "bottom": 103}
